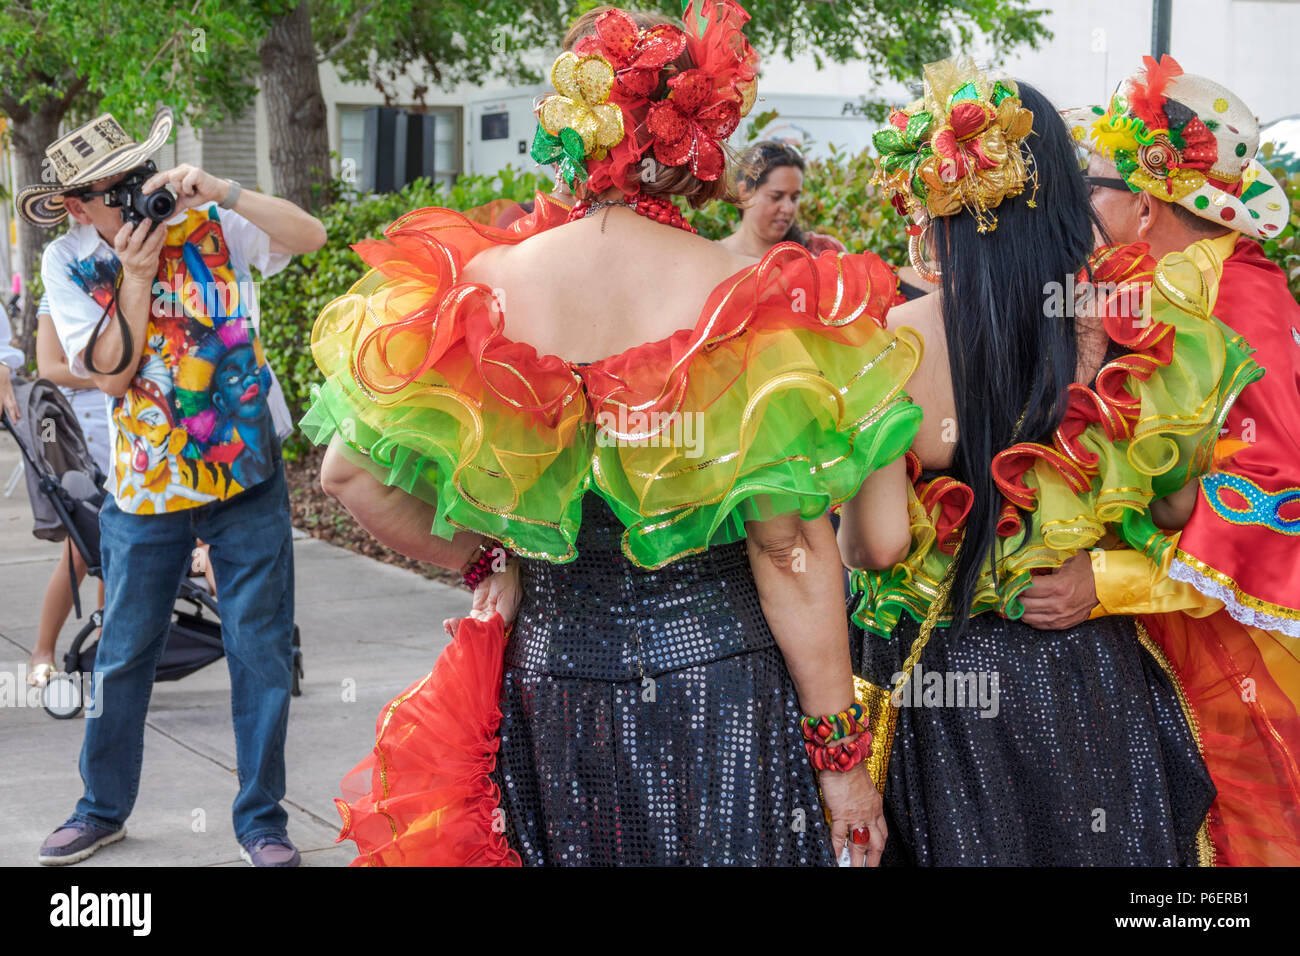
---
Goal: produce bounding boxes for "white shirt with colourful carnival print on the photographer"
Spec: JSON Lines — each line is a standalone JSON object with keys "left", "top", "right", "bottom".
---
{"left": 42, "top": 204, "right": 289, "bottom": 515}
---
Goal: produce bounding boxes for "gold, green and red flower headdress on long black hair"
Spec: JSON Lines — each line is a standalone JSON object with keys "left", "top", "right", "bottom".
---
{"left": 872, "top": 57, "right": 1037, "bottom": 233}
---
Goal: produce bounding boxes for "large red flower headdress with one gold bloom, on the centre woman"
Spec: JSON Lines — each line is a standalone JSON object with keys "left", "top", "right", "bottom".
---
{"left": 532, "top": 0, "right": 758, "bottom": 195}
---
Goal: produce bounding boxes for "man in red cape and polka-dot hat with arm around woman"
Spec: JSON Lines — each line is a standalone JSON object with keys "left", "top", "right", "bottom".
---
{"left": 1024, "top": 56, "right": 1300, "bottom": 866}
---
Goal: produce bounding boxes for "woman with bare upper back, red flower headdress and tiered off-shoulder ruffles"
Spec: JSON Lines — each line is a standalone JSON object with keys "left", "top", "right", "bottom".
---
{"left": 304, "top": 3, "right": 920, "bottom": 865}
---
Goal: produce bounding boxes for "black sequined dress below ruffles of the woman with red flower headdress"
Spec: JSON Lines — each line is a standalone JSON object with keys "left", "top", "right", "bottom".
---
{"left": 495, "top": 496, "right": 835, "bottom": 866}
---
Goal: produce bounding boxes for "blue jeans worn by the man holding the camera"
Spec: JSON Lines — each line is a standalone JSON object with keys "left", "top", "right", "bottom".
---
{"left": 73, "top": 464, "right": 294, "bottom": 843}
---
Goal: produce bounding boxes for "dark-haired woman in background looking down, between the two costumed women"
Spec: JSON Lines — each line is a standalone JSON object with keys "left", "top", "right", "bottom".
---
{"left": 720, "top": 139, "right": 844, "bottom": 259}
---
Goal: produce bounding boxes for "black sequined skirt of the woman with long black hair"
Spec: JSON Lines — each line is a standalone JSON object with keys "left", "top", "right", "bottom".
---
{"left": 852, "top": 614, "right": 1214, "bottom": 866}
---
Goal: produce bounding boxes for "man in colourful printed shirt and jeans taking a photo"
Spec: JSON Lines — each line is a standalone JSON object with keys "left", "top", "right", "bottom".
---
{"left": 16, "top": 109, "right": 325, "bottom": 866}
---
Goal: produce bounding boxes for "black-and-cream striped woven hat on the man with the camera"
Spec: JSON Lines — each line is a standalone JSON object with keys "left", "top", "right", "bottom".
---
{"left": 14, "top": 107, "right": 173, "bottom": 226}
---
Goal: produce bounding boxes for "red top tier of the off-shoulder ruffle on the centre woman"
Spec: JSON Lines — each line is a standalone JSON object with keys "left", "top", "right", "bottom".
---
{"left": 354, "top": 195, "right": 900, "bottom": 427}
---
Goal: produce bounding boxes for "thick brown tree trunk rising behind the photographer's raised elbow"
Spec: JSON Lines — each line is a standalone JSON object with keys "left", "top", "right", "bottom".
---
{"left": 259, "top": 0, "right": 330, "bottom": 209}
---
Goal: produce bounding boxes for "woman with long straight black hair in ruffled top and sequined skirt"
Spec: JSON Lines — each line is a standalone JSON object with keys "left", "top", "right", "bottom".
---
{"left": 840, "top": 61, "right": 1253, "bottom": 865}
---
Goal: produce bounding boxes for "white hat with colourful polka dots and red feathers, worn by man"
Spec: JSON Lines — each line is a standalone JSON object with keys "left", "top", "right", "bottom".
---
{"left": 1062, "top": 56, "right": 1290, "bottom": 239}
